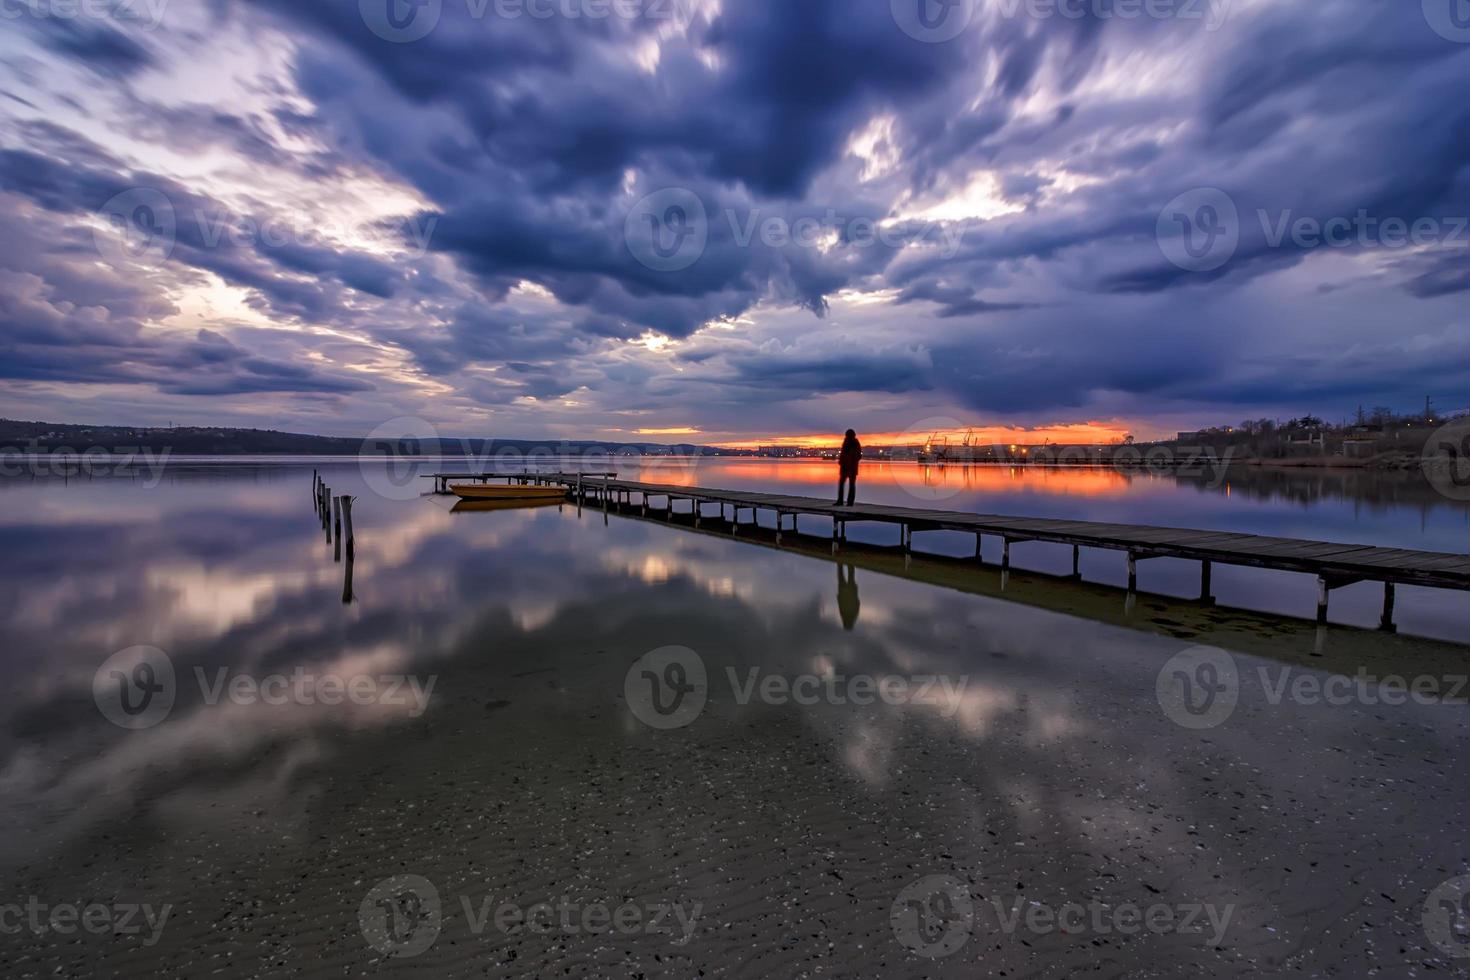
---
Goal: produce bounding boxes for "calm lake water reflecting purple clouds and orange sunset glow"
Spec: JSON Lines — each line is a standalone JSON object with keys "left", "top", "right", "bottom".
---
{"left": 0, "top": 460, "right": 1470, "bottom": 979}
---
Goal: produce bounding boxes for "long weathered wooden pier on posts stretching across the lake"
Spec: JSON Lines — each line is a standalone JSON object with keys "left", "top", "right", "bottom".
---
{"left": 431, "top": 473, "right": 1470, "bottom": 632}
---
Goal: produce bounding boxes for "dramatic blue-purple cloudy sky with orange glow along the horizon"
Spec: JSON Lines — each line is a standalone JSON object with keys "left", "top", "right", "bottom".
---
{"left": 0, "top": 0, "right": 1470, "bottom": 442}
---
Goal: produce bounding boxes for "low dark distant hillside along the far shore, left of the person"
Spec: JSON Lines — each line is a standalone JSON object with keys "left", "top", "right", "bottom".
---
{"left": 0, "top": 419, "right": 735, "bottom": 458}
